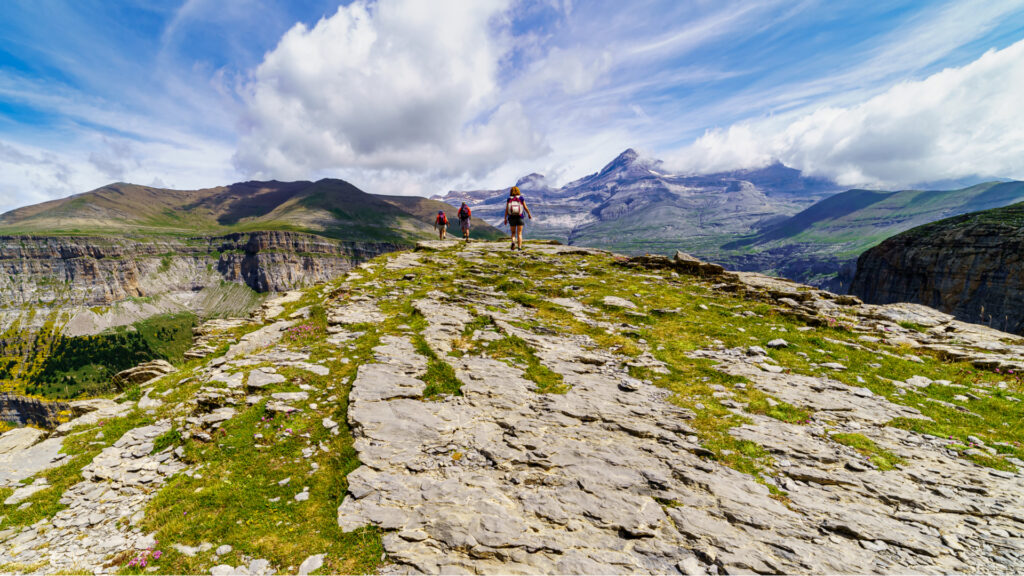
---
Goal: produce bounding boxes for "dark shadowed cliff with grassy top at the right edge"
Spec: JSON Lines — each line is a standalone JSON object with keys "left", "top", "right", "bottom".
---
{"left": 850, "top": 204, "right": 1024, "bottom": 334}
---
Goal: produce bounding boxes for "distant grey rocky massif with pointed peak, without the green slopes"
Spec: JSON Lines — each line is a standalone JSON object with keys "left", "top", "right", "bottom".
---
{"left": 434, "top": 149, "right": 840, "bottom": 253}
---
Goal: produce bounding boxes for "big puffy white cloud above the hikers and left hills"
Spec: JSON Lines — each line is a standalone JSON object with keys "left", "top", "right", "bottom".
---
{"left": 234, "top": 0, "right": 548, "bottom": 193}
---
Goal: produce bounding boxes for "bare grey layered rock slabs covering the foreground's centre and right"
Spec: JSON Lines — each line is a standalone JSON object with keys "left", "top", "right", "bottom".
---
{"left": 338, "top": 243, "right": 1024, "bottom": 574}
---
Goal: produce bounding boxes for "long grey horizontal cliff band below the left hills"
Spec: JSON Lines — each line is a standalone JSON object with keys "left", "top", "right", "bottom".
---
{"left": 0, "top": 232, "right": 400, "bottom": 307}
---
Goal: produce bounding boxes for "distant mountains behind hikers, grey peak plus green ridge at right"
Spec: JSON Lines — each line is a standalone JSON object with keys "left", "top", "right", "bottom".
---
{"left": 434, "top": 149, "right": 1024, "bottom": 292}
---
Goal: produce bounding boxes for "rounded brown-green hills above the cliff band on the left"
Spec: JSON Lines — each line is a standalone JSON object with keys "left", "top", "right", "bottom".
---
{"left": 0, "top": 178, "right": 501, "bottom": 244}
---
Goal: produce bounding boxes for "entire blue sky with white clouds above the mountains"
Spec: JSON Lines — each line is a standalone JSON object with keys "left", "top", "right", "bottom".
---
{"left": 0, "top": 0, "right": 1024, "bottom": 210}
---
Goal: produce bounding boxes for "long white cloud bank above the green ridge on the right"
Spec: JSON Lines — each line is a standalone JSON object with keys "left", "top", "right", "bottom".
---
{"left": 670, "top": 41, "right": 1024, "bottom": 187}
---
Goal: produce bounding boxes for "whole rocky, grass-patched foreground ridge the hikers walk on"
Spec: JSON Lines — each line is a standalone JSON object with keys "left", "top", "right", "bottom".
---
{"left": 0, "top": 242, "right": 1024, "bottom": 576}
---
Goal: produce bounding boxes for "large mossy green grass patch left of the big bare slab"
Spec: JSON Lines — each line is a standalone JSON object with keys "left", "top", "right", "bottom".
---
{"left": 134, "top": 290, "right": 396, "bottom": 574}
